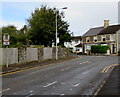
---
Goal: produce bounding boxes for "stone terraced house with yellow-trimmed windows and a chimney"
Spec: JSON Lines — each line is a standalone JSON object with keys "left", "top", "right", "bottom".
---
{"left": 82, "top": 20, "right": 120, "bottom": 54}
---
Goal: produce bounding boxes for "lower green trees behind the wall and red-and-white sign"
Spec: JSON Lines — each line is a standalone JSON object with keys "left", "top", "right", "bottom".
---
{"left": 2, "top": 25, "right": 28, "bottom": 47}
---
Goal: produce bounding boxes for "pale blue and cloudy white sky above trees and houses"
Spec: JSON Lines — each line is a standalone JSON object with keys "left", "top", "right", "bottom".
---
{"left": 0, "top": 0, "right": 119, "bottom": 36}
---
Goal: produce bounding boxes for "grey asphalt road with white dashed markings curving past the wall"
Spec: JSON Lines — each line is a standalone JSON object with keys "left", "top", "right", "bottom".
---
{"left": 0, "top": 56, "right": 118, "bottom": 97}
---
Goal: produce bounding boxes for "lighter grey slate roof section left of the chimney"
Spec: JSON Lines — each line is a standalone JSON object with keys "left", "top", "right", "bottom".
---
{"left": 82, "top": 27, "right": 104, "bottom": 37}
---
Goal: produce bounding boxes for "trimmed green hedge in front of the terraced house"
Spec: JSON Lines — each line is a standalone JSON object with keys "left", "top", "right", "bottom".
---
{"left": 91, "top": 45, "right": 109, "bottom": 53}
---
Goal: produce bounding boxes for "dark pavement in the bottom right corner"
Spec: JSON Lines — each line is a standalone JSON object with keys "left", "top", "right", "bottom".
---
{"left": 96, "top": 66, "right": 120, "bottom": 97}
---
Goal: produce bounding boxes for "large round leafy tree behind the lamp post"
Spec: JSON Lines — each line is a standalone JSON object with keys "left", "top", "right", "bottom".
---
{"left": 27, "top": 6, "right": 71, "bottom": 46}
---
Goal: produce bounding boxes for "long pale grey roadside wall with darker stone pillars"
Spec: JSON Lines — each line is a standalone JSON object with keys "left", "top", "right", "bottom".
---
{"left": 0, "top": 48, "right": 68, "bottom": 65}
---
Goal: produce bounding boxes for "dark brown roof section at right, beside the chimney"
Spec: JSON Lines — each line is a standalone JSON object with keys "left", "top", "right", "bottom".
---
{"left": 98, "top": 25, "right": 120, "bottom": 35}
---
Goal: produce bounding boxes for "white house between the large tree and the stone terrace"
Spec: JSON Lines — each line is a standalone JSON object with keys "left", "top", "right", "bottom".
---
{"left": 64, "top": 36, "right": 82, "bottom": 53}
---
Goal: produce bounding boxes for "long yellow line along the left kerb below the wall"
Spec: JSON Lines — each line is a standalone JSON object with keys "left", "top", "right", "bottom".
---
{"left": 0, "top": 57, "right": 81, "bottom": 76}
